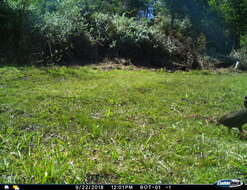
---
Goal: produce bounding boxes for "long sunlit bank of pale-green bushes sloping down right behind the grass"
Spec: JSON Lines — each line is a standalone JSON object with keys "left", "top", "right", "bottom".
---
{"left": 36, "top": 7, "right": 202, "bottom": 68}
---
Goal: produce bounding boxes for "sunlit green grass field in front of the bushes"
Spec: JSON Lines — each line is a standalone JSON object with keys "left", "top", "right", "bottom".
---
{"left": 0, "top": 66, "right": 247, "bottom": 184}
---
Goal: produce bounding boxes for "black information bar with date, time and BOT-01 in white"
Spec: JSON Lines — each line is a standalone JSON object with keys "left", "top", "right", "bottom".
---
{"left": 0, "top": 184, "right": 247, "bottom": 190}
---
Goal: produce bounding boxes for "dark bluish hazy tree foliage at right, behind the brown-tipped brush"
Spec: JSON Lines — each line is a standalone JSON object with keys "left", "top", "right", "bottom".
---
{"left": 159, "top": 0, "right": 232, "bottom": 53}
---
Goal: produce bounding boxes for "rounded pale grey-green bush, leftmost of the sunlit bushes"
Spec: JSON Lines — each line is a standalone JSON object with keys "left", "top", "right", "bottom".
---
{"left": 37, "top": 1, "right": 91, "bottom": 63}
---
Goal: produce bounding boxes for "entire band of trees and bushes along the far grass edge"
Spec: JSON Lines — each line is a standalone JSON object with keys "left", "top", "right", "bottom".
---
{"left": 0, "top": 0, "right": 247, "bottom": 69}
